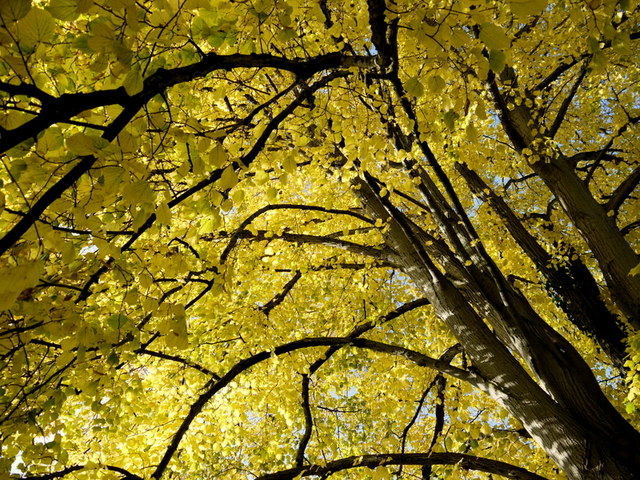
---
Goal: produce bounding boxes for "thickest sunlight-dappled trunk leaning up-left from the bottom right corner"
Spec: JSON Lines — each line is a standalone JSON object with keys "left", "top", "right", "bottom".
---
{"left": 359, "top": 176, "right": 640, "bottom": 480}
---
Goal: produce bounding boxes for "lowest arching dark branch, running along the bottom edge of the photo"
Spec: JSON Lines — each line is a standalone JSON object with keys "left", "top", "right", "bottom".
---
{"left": 255, "top": 453, "right": 547, "bottom": 480}
